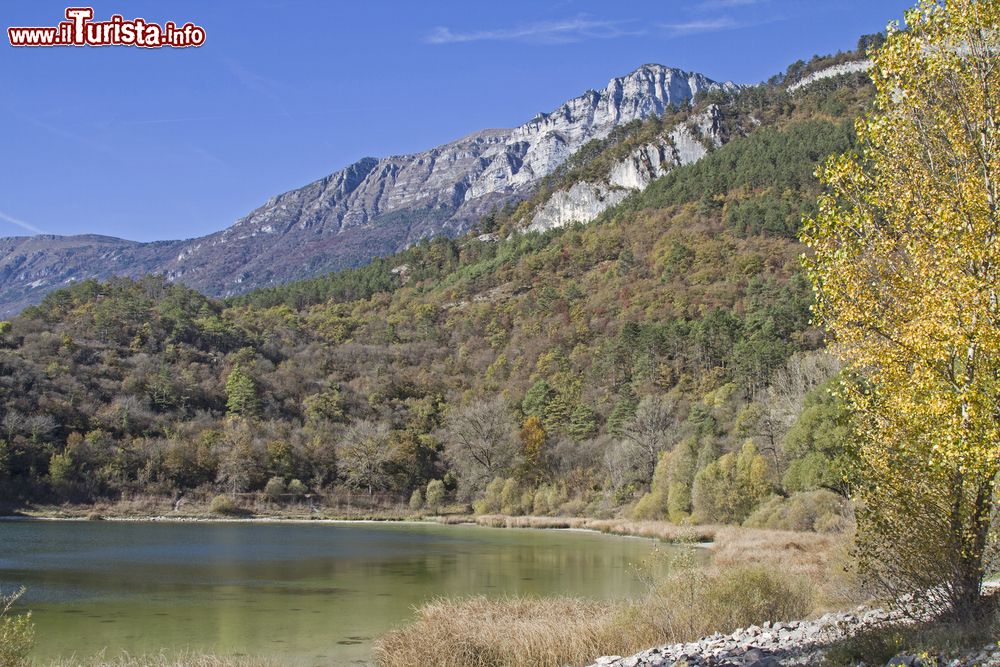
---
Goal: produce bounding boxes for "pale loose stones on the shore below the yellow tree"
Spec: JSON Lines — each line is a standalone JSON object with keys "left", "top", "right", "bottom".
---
{"left": 591, "top": 608, "right": 1000, "bottom": 667}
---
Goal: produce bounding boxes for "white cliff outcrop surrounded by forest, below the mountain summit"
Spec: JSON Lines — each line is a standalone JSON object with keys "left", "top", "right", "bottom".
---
{"left": 527, "top": 105, "right": 723, "bottom": 231}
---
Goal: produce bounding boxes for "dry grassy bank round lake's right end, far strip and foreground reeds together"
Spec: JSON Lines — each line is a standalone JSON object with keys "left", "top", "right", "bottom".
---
{"left": 375, "top": 516, "right": 860, "bottom": 667}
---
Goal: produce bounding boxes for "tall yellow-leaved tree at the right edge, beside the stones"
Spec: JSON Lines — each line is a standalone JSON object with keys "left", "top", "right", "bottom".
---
{"left": 803, "top": 0, "right": 1000, "bottom": 617}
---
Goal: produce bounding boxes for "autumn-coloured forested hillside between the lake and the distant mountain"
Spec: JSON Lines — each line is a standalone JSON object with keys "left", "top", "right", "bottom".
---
{"left": 0, "top": 54, "right": 871, "bottom": 530}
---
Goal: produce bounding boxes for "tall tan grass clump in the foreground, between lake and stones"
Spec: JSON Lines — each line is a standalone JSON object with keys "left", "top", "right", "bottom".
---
{"left": 375, "top": 550, "right": 815, "bottom": 667}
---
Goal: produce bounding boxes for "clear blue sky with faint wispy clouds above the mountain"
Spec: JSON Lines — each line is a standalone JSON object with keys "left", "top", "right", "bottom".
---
{"left": 0, "top": 0, "right": 913, "bottom": 241}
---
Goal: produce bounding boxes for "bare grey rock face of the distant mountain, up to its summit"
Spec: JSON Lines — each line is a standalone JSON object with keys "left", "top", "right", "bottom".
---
{"left": 217, "top": 65, "right": 733, "bottom": 240}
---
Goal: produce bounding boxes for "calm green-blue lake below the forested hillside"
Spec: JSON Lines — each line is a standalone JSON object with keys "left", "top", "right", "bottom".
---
{"left": 0, "top": 521, "right": 676, "bottom": 666}
